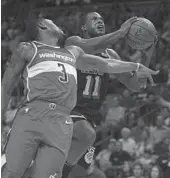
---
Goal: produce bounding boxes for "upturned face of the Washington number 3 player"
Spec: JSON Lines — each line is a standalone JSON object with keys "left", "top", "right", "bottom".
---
{"left": 42, "top": 19, "right": 64, "bottom": 38}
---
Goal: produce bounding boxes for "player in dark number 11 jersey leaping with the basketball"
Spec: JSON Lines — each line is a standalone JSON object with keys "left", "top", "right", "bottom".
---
{"left": 63, "top": 12, "right": 158, "bottom": 178}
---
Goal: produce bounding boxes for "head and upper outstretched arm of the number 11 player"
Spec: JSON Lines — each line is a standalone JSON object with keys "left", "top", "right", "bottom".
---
{"left": 66, "top": 12, "right": 137, "bottom": 54}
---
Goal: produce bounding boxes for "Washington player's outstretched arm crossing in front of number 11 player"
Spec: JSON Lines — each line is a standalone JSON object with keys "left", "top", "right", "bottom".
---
{"left": 66, "top": 46, "right": 158, "bottom": 75}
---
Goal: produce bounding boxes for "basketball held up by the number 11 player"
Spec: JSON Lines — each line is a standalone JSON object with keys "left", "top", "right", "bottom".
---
{"left": 126, "top": 18, "right": 157, "bottom": 50}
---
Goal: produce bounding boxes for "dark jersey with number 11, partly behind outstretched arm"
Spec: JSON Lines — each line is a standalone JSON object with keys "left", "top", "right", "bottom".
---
{"left": 74, "top": 53, "right": 109, "bottom": 116}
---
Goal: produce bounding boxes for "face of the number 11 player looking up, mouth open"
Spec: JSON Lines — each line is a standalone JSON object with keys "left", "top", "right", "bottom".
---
{"left": 86, "top": 12, "right": 105, "bottom": 37}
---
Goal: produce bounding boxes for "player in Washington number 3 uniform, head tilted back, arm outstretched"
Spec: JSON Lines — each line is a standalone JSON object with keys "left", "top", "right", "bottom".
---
{"left": 1, "top": 19, "right": 157, "bottom": 178}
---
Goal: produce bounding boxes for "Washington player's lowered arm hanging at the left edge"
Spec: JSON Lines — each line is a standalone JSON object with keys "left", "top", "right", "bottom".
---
{"left": 1, "top": 43, "right": 34, "bottom": 122}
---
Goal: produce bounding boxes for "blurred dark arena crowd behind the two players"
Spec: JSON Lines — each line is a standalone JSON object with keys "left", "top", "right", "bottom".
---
{"left": 1, "top": 0, "right": 170, "bottom": 178}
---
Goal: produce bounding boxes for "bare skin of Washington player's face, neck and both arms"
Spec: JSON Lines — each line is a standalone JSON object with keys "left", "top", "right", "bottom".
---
{"left": 1, "top": 19, "right": 156, "bottom": 121}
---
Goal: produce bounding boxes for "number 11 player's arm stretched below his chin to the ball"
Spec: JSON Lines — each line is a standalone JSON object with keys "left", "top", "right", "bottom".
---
{"left": 65, "top": 17, "right": 137, "bottom": 54}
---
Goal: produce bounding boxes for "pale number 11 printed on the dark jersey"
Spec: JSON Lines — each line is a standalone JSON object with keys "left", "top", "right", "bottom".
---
{"left": 83, "top": 75, "right": 101, "bottom": 99}
